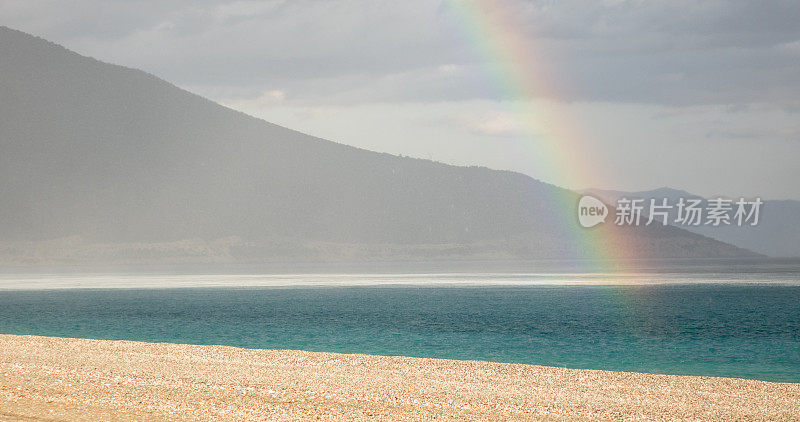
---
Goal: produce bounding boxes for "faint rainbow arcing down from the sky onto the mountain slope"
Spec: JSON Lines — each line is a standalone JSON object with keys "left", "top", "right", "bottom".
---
{"left": 444, "top": 0, "right": 639, "bottom": 271}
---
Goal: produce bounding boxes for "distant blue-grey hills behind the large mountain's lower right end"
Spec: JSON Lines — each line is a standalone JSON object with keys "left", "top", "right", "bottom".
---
{"left": 584, "top": 188, "right": 800, "bottom": 257}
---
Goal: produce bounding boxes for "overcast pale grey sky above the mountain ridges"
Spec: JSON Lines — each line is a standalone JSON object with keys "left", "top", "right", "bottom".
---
{"left": 0, "top": 0, "right": 800, "bottom": 199}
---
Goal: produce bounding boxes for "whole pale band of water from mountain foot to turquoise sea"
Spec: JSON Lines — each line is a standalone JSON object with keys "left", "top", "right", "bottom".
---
{"left": 0, "top": 259, "right": 800, "bottom": 290}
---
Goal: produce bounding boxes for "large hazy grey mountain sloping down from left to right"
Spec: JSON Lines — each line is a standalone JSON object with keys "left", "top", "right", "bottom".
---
{"left": 0, "top": 27, "right": 752, "bottom": 263}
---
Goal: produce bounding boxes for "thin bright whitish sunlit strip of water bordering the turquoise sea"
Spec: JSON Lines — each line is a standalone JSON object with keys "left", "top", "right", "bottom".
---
{"left": 0, "top": 272, "right": 800, "bottom": 292}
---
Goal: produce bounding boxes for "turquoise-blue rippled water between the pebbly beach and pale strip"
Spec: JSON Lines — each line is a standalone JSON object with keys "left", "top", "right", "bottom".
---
{"left": 0, "top": 284, "right": 800, "bottom": 382}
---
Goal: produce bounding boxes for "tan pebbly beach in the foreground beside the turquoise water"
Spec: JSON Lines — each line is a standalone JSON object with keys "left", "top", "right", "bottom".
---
{"left": 0, "top": 335, "right": 800, "bottom": 421}
